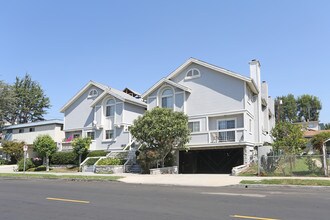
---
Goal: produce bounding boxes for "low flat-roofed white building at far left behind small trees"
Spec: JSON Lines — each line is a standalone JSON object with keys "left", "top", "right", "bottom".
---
{"left": 2, "top": 119, "right": 64, "bottom": 157}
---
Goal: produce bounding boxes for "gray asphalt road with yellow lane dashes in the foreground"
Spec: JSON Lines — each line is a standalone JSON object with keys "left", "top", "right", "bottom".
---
{"left": 0, "top": 179, "right": 330, "bottom": 220}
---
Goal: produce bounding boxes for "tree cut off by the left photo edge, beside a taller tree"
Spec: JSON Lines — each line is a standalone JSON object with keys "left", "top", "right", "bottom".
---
{"left": 0, "top": 81, "right": 16, "bottom": 127}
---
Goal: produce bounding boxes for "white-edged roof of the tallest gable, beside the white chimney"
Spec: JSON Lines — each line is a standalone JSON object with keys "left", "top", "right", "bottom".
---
{"left": 166, "top": 58, "right": 259, "bottom": 94}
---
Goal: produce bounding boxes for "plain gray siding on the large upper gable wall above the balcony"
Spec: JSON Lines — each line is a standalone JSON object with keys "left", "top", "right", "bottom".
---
{"left": 172, "top": 64, "right": 245, "bottom": 115}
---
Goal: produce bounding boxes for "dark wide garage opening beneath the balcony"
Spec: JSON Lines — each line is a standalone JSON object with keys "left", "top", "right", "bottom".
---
{"left": 179, "top": 148, "right": 243, "bottom": 173}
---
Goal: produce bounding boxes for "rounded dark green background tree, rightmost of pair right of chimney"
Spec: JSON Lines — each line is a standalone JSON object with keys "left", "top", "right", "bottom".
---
{"left": 297, "top": 94, "right": 322, "bottom": 121}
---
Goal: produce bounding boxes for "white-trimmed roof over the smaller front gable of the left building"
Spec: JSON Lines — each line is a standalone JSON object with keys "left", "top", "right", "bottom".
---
{"left": 91, "top": 87, "right": 147, "bottom": 107}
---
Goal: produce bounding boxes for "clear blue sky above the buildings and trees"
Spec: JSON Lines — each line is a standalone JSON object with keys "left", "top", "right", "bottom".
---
{"left": 0, "top": 0, "right": 330, "bottom": 122}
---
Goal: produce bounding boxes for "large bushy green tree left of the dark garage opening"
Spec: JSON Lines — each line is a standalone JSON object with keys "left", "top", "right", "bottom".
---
{"left": 130, "top": 107, "right": 190, "bottom": 167}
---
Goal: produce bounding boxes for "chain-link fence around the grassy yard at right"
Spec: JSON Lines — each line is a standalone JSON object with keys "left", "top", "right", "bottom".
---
{"left": 258, "top": 155, "right": 330, "bottom": 176}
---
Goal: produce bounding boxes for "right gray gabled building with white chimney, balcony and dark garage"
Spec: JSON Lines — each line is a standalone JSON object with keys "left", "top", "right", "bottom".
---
{"left": 142, "top": 58, "right": 275, "bottom": 173}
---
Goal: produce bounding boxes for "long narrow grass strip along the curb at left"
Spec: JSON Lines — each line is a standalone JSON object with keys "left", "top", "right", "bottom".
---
{"left": 0, "top": 173, "right": 122, "bottom": 181}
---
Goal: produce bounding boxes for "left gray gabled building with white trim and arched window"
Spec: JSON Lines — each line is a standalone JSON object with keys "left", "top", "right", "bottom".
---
{"left": 61, "top": 81, "right": 147, "bottom": 151}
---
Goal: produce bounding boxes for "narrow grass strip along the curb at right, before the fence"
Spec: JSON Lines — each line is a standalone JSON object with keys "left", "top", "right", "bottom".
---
{"left": 240, "top": 179, "right": 330, "bottom": 186}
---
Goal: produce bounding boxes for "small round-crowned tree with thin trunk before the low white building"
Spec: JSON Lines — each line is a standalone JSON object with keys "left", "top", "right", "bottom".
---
{"left": 33, "top": 134, "right": 57, "bottom": 171}
